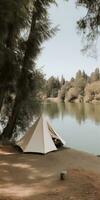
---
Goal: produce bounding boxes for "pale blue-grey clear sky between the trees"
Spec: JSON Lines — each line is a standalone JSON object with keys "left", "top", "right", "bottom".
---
{"left": 38, "top": 0, "right": 100, "bottom": 80}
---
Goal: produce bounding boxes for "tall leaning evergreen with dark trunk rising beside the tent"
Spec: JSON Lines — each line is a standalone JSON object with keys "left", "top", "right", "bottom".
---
{"left": 3, "top": 0, "right": 56, "bottom": 139}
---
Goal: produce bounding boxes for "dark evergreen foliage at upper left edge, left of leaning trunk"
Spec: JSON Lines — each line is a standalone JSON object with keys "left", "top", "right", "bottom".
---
{"left": 0, "top": 0, "right": 31, "bottom": 110}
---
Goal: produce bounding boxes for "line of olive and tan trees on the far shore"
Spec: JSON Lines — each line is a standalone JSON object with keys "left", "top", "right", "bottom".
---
{"left": 45, "top": 68, "right": 100, "bottom": 102}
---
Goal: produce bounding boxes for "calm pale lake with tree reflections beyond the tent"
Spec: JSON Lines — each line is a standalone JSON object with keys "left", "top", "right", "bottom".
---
{"left": 43, "top": 101, "right": 100, "bottom": 155}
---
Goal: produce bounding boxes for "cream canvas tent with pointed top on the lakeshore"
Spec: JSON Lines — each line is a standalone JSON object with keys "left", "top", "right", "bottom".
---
{"left": 17, "top": 115, "right": 65, "bottom": 154}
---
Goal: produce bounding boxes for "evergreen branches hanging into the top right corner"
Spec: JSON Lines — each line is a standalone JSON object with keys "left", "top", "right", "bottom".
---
{"left": 76, "top": 0, "right": 100, "bottom": 50}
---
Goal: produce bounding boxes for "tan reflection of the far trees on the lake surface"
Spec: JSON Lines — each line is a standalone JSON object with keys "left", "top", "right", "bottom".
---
{"left": 43, "top": 101, "right": 100, "bottom": 124}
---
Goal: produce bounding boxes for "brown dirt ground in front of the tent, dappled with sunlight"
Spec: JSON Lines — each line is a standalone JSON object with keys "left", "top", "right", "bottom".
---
{"left": 0, "top": 147, "right": 100, "bottom": 200}
